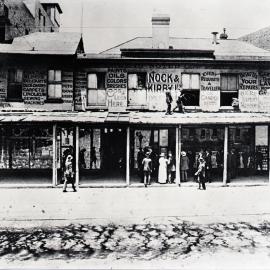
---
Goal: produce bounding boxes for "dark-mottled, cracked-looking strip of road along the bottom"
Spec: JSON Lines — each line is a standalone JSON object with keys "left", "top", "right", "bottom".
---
{"left": 0, "top": 219, "right": 270, "bottom": 261}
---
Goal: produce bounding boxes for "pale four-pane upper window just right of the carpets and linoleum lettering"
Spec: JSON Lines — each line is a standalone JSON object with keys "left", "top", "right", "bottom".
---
{"left": 48, "top": 69, "right": 62, "bottom": 100}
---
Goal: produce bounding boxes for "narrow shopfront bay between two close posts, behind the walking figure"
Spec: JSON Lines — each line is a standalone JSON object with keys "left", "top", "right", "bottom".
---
{"left": 57, "top": 127, "right": 76, "bottom": 185}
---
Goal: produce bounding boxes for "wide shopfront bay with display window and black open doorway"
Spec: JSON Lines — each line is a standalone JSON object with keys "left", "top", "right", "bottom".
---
{"left": 79, "top": 127, "right": 126, "bottom": 184}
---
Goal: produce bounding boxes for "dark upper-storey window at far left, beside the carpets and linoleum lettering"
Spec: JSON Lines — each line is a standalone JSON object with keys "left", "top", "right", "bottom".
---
{"left": 7, "top": 69, "right": 23, "bottom": 101}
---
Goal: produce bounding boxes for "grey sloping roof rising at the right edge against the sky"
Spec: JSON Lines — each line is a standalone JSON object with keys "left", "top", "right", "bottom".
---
{"left": 239, "top": 26, "right": 270, "bottom": 51}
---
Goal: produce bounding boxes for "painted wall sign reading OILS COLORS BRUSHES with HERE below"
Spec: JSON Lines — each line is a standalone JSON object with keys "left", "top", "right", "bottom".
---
{"left": 106, "top": 69, "right": 127, "bottom": 112}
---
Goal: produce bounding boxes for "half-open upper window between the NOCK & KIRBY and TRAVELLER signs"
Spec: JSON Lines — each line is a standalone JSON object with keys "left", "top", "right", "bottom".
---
{"left": 182, "top": 74, "right": 200, "bottom": 106}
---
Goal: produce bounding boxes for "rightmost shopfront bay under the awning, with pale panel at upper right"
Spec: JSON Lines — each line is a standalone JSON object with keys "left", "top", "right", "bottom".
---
{"left": 227, "top": 125, "right": 268, "bottom": 183}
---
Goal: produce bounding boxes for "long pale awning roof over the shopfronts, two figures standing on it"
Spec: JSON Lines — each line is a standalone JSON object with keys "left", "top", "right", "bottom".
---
{"left": 0, "top": 111, "right": 270, "bottom": 125}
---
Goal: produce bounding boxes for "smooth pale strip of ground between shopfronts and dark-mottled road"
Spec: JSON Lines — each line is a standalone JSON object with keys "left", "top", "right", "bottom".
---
{"left": 0, "top": 186, "right": 270, "bottom": 227}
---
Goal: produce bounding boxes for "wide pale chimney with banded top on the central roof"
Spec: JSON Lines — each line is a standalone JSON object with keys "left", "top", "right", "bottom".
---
{"left": 152, "top": 14, "right": 170, "bottom": 49}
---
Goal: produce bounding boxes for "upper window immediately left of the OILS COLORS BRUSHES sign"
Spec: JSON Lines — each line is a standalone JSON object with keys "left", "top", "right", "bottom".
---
{"left": 87, "top": 72, "right": 105, "bottom": 105}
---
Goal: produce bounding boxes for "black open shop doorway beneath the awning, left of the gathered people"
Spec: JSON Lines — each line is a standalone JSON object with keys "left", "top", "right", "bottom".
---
{"left": 101, "top": 128, "right": 126, "bottom": 175}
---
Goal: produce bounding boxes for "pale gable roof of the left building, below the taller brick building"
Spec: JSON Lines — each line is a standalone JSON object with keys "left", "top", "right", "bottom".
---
{"left": 0, "top": 32, "right": 83, "bottom": 55}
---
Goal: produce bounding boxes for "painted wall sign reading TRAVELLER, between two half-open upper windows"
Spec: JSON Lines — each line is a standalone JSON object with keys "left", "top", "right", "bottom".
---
{"left": 200, "top": 71, "right": 220, "bottom": 112}
